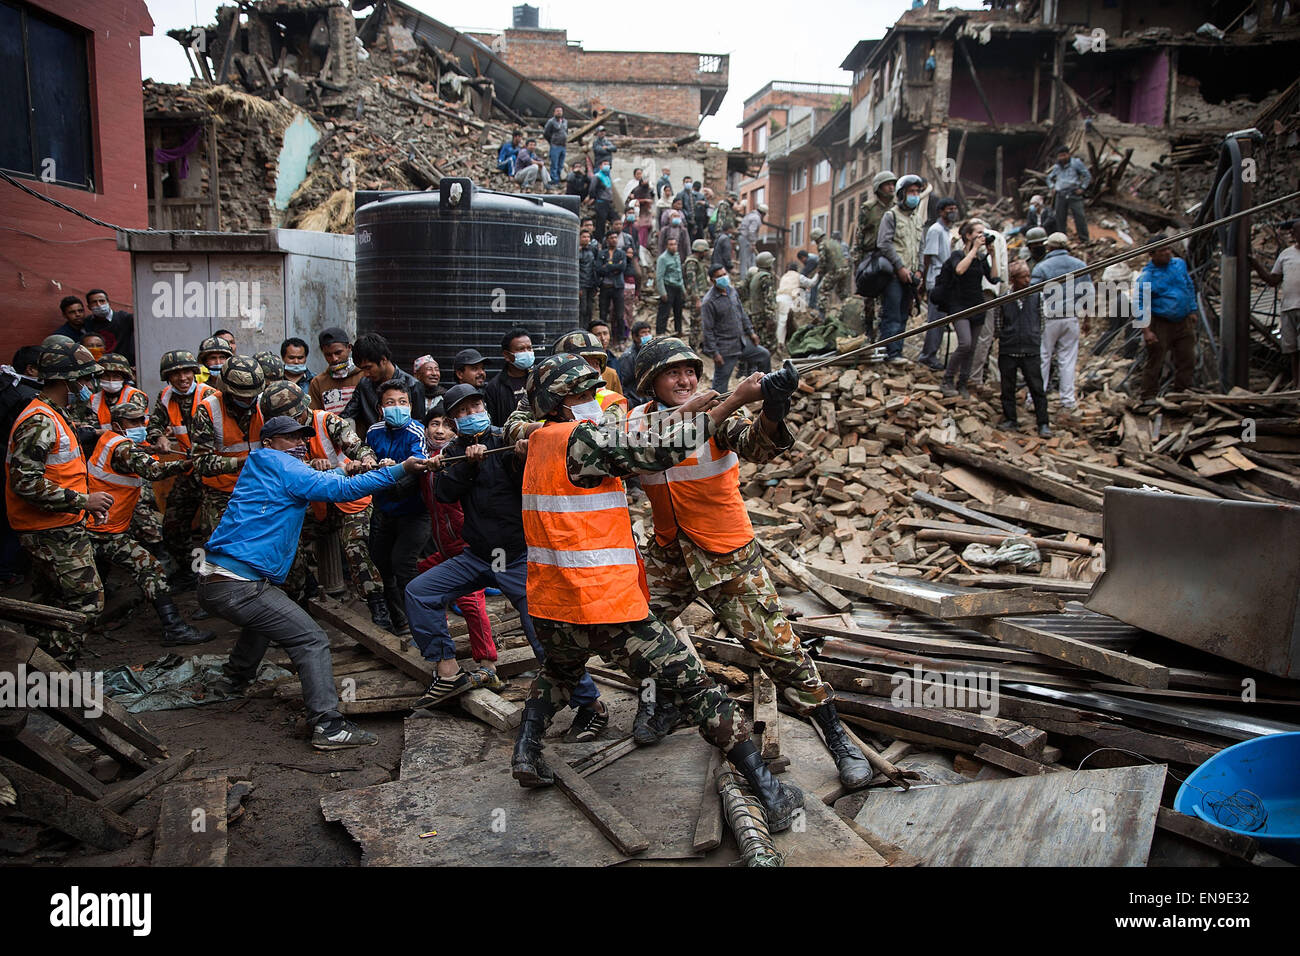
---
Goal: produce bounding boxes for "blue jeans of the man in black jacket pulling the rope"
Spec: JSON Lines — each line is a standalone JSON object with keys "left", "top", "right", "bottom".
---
{"left": 406, "top": 549, "right": 601, "bottom": 708}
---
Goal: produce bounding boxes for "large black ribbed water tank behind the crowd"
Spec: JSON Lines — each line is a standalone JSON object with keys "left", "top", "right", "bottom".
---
{"left": 355, "top": 178, "right": 579, "bottom": 385}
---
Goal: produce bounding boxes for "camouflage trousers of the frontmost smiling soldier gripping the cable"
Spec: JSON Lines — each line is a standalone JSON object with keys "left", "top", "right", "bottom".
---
{"left": 644, "top": 540, "right": 835, "bottom": 714}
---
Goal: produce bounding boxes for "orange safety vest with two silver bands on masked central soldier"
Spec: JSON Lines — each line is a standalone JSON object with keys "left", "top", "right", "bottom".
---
{"left": 524, "top": 421, "right": 650, "bottom": 624}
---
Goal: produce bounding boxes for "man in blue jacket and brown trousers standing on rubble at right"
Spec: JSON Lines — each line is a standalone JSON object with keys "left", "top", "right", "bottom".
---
{"left": 1134, "top": 246, "right": 1196, "bottom": 402}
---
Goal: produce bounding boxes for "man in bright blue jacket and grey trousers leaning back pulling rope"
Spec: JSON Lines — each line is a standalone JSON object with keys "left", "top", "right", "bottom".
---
{"left": 199, "top": 415, "right": 429, "bottom": 750}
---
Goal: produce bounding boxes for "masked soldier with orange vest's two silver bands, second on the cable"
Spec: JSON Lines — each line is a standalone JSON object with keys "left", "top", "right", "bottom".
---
{"left": 512, "top": 356, "right": 803, "bottom": 832}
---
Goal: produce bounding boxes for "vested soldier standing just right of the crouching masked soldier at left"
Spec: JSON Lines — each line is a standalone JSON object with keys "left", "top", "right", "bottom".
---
{"left": 146, "top": 350, "right": 215, "bottom": 591}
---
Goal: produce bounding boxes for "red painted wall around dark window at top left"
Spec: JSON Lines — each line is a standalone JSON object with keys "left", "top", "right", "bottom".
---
{"left": 0, "top": 0, "right": 153, "bottom": 364}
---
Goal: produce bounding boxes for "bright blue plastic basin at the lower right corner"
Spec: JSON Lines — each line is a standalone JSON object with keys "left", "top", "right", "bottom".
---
{"left": 1174, "top": 734, "right": 1300, "bottom": 864}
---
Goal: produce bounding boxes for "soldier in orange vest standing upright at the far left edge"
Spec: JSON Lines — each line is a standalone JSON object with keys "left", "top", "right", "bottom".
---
{"left": 5, "top": 345, "right": 113, "bottom": 661}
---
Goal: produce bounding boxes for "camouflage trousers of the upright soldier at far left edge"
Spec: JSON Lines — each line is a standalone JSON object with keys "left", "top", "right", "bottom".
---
{"left": 18, "top": 524, "right": 104, "bottom": 659}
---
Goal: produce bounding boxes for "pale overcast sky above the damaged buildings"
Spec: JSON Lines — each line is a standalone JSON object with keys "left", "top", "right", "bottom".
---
{"left": 140, "top": 0, "right": 904, "bottom": 148}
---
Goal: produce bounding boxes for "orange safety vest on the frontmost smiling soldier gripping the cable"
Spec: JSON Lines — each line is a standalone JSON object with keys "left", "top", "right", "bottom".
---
{"left": 628, "top": 402, "right": 754, "bottom": 554}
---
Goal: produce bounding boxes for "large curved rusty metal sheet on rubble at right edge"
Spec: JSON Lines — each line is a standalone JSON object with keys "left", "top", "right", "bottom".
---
{"left": 1084, "top": 488, "right": 1300, "bottom": 678}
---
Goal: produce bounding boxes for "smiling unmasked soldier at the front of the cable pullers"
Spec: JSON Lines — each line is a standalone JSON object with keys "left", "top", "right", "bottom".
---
{"left": 628, "top": 338, "right": 872, "bottom": 787}
